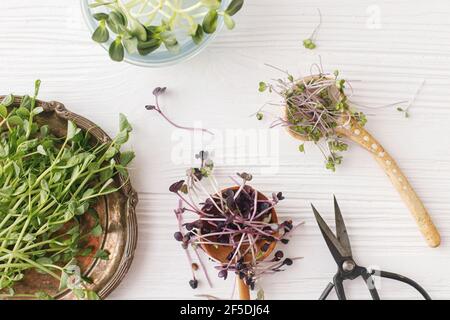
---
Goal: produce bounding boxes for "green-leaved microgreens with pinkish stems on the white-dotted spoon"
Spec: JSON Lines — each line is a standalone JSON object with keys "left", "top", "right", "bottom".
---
{"left": 258, "top": 68, "right": 367, "bottom": 171}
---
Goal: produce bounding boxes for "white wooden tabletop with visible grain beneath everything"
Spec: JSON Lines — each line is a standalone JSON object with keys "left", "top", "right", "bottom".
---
{"left": 0, "top": 0, "right": 450, "bottom": 299}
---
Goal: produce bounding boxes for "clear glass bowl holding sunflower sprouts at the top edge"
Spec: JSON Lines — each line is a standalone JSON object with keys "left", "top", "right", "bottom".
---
{"left": 81, "top": 0, "right": 231, "bottom": 68}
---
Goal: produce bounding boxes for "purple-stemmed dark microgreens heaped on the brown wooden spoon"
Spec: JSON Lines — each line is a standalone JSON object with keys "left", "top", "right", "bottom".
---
{"left": 169, "top": 152, "right": 296, "bottom": 289}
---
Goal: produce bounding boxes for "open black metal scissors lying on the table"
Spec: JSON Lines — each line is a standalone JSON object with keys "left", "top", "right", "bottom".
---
{"left": 311, "top": 197, "right": 431, "bottom": 300}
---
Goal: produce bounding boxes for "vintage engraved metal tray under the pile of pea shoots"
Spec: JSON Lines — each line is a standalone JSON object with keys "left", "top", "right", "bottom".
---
{"left": 0, "top": 96, "right": 138, "bottom": 299}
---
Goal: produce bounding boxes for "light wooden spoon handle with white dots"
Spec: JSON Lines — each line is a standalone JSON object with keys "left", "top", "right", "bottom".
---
{"left": 338, "top": 121, "right": 441, "bottom": 248}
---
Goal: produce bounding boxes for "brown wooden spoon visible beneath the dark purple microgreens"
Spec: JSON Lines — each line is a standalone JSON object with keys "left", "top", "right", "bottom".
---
{"left": 201, "top": 187, "right": 278, "bottom": 300}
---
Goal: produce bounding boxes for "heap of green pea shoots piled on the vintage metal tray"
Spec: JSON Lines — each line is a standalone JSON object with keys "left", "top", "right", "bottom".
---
{"left": 0, "top": 81, "right": 134, "bottom": 299}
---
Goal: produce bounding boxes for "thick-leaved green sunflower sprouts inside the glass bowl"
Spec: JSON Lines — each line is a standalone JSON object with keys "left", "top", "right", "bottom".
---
{"left": 90, "top": 0, "right": 244, "bottom": 61}
